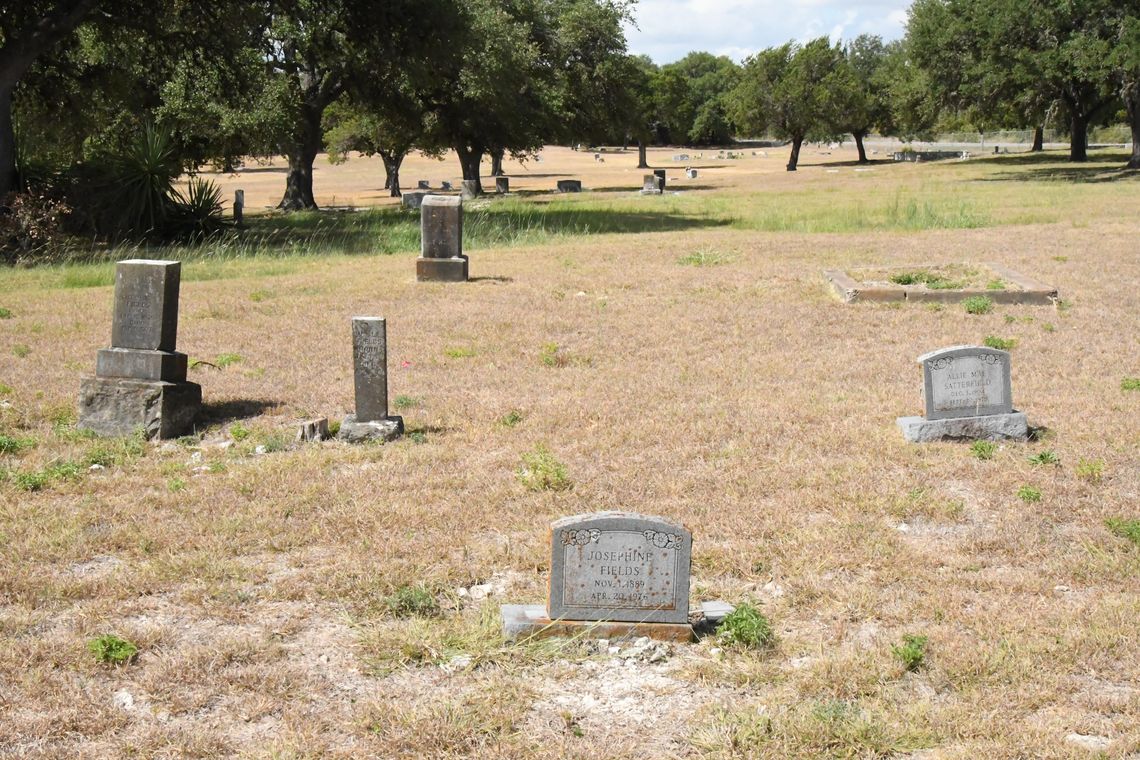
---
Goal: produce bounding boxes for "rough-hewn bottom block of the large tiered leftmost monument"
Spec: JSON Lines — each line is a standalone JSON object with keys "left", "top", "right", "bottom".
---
{"left": 78, "top": 377, "right": 202, "bottom": 439}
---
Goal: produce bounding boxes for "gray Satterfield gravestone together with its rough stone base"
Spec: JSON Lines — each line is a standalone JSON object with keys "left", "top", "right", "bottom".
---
{"left": 897, "top": 345, "right": 1029, "bottom": 443}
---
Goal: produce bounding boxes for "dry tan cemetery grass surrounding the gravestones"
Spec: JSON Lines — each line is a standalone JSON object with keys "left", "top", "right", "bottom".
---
{"left": 0, "top": 148, "right": 1140, "bottom": 760}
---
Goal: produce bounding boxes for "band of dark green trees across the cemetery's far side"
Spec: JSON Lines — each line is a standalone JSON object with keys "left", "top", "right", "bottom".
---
{"left": 0, "top": 0, "right": 1140, "bottom": 247}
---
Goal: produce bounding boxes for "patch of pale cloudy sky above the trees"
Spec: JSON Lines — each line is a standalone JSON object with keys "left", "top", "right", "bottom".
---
{"left": 626, "top": 0, "right": 911, "bottom": 64}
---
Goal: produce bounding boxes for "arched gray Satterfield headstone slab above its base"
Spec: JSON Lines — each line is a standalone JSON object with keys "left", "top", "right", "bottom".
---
{"left": 918, "top": 345, "right": 1013, "bottom": 419}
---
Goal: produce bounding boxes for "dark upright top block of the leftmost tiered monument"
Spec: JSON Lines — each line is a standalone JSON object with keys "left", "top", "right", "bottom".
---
{"left": 111, "top": 259, "right": 182, "bottom": 351}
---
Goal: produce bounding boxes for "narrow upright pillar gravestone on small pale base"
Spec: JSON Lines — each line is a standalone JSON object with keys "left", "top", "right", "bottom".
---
{"left": 336, "top": 317, "right": 404, "bottom": 443}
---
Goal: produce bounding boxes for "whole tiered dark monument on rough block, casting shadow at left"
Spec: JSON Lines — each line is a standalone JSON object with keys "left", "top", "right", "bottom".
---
{"left": 78, "top": 259, "right": 202, "bottom": 439}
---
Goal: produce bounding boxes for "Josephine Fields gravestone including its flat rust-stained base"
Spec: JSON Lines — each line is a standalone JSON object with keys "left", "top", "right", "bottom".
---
{"left": 502, "top": 512, "right": 731, "bottom": 641}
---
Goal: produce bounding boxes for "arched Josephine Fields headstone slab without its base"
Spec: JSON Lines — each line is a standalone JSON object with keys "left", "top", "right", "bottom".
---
{"left": 547, "top": 512, "right": 692, "bottom": 624}
